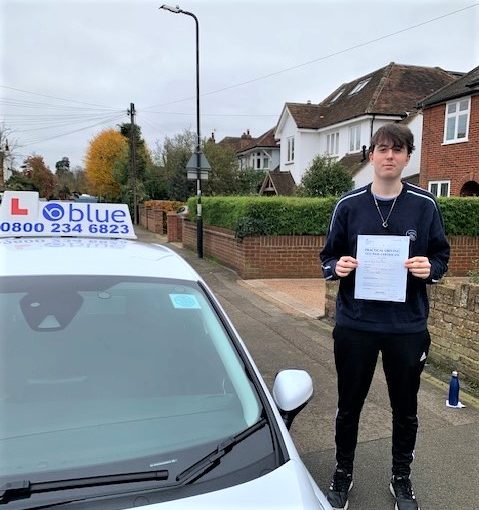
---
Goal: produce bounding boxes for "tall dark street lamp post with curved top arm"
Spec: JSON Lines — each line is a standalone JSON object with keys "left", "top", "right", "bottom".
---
{"left": 160, "top": 4, "right": 203, "bottom": 259}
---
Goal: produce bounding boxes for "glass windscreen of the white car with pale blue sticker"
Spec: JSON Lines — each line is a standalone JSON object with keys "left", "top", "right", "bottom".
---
{"left": 0, "top": 276, "right": 271, "bottom": 479}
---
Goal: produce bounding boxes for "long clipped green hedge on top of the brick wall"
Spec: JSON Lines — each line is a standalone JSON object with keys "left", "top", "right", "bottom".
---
{"left": 188, "top": 196, "right": 479, "bottom": 239}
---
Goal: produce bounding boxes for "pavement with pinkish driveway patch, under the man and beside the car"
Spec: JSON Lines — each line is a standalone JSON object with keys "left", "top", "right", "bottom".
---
{"left": 136, "top": 227, "right": 479, "bottom": 510}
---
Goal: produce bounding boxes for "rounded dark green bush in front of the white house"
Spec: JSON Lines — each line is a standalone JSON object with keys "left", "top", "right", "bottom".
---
{"left": 298, "top": 155, "right": 354, "bottom": 197}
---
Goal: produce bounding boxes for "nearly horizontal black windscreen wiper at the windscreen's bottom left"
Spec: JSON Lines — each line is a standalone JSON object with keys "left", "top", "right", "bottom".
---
{"left": 0, "top": 469, "right": 168, "bottom": 505}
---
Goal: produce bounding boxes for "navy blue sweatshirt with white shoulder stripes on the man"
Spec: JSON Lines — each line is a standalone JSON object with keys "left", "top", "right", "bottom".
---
{"left": 320, "top": 182, "right": 450, "bottom": 333}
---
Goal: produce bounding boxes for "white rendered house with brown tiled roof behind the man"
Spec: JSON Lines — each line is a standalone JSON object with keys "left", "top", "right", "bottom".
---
{"left": 274, "top": 63, "right": 458, "bottom": 188}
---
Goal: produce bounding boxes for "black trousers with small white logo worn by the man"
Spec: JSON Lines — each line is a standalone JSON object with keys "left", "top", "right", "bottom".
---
{"left": 333, "top": 325, "right": 431, "bottom": 476}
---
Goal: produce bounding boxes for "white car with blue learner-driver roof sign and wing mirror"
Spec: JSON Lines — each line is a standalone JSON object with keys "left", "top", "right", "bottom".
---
{"left": 0, "top": 191, "right": 331, "bottom": 510}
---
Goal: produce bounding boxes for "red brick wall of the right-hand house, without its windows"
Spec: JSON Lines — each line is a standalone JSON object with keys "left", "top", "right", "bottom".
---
{"left": 419, "top": 96, "right": 479, "bottom": 196}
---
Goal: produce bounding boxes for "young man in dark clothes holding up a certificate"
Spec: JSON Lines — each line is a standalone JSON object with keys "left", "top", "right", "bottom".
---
{"left": 320, "top": 123, "right": 449, "bottom": 510}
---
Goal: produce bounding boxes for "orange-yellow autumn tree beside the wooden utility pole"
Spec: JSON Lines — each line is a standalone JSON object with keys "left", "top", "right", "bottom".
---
{"left": 85, "top": 128, "right": 128, "bottom": 201}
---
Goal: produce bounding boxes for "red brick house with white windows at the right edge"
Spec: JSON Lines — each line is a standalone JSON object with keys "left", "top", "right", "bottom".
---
{"left": 419, "top": 67, "right": 479, "bottom": 196}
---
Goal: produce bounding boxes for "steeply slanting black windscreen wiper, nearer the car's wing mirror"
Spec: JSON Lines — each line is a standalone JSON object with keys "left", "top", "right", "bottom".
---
{"left": 176, "top": 418, "right": 268, "bottom": 485}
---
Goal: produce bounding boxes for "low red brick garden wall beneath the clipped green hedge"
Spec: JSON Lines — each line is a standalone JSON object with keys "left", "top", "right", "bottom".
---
{"left": 183, "top": 221, "right": 479, "bottom": 279}
